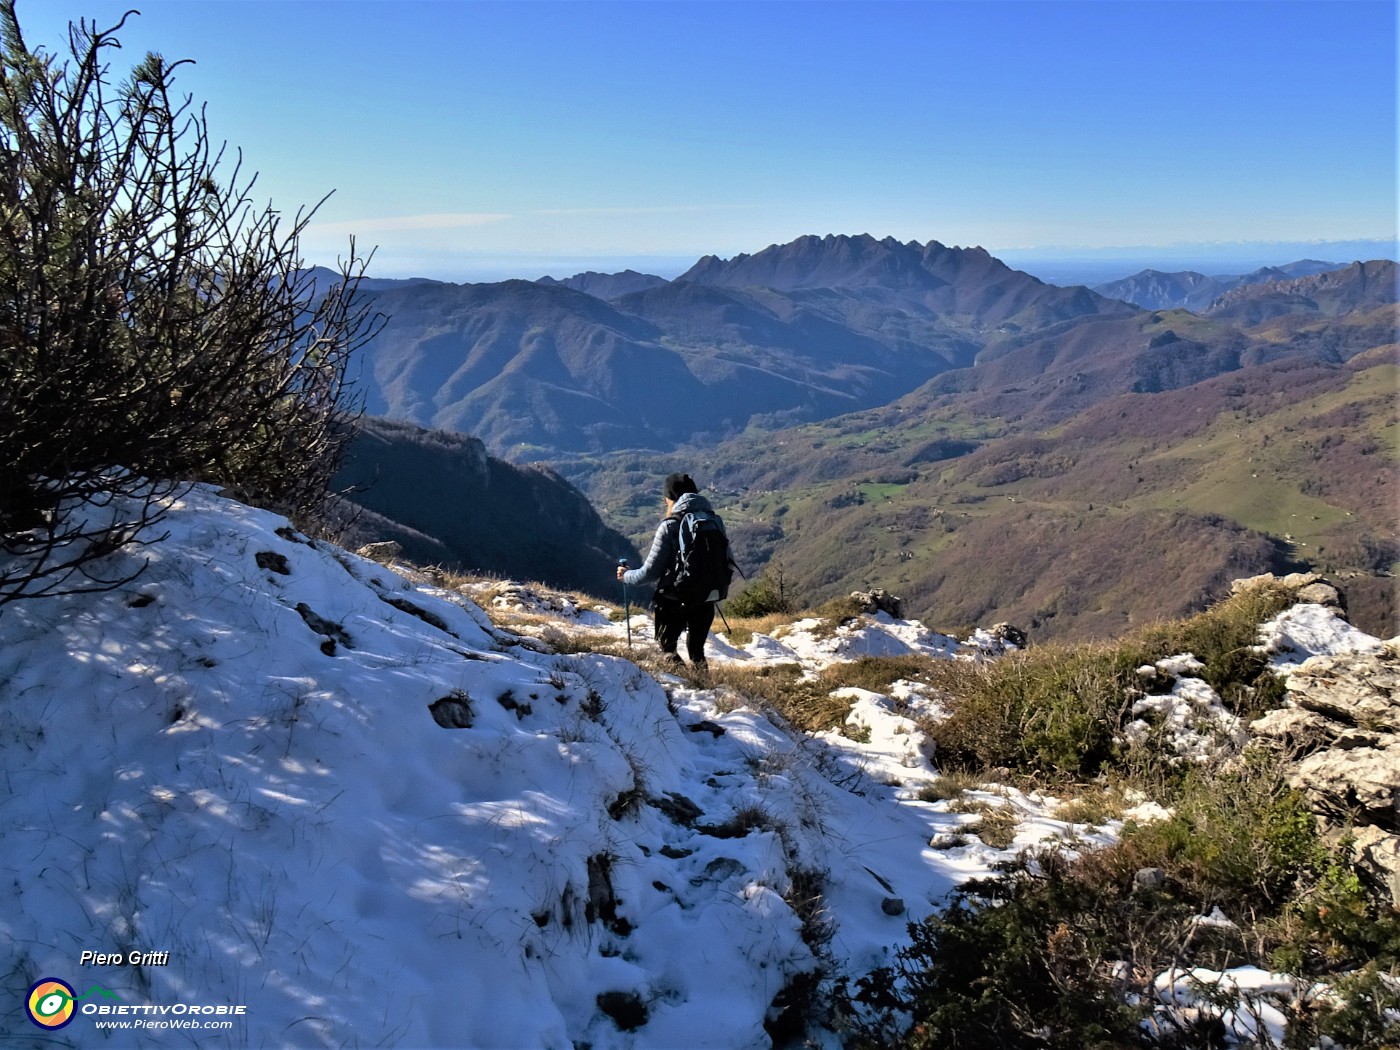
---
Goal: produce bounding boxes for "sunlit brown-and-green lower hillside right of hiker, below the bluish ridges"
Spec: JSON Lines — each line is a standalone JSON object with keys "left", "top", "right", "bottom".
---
{"left": 570, "top": 349, "right": 1400, "bottom": 641}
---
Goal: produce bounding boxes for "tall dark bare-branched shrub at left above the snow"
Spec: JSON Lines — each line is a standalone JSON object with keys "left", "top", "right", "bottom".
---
{"left": 0, "top": 0, "right": 374, "bottom": 603}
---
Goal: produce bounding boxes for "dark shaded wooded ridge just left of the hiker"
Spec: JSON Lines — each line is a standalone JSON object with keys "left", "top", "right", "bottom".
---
{"left": 335, "top": 419, "right": 638, "bottom": 596}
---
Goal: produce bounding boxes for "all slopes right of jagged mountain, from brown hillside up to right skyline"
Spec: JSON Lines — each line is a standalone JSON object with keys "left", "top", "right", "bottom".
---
{"left": 561, "top": 262, "right": 1400, "bottom": 638}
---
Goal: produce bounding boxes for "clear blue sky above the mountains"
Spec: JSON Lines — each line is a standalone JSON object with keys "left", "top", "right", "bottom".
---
{"left": 18, "top": 0, "right": 1397, "bottom": 280}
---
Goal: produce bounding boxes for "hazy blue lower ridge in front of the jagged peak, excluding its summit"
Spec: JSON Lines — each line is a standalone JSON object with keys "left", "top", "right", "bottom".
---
{"left": 352, "top": 281, "right": 979, "bottom": 459}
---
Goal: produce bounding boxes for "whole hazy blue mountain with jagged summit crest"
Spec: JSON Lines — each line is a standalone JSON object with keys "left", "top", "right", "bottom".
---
{"left": 347, "top": 237, "right": 1134, "bottom": 459}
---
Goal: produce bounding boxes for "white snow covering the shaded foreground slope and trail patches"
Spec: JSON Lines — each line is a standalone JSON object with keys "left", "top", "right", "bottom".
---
{"left": 0, "top": 487, "right": 1388, "bottom": 1050}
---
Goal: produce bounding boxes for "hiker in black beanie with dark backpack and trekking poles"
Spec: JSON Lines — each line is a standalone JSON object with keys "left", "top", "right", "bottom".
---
{"left": 617, "top": 473, "right": 731, "bottom": 668}
